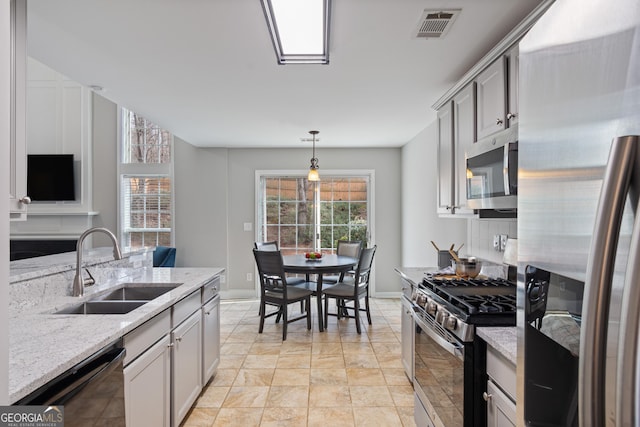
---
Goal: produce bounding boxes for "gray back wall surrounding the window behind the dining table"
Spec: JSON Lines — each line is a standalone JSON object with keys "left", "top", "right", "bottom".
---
{"left": 175, "top": 141, "right": 401, "bottom": 298}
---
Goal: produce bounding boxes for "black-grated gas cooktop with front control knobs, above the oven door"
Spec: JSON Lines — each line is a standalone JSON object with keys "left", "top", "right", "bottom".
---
{"left": 411, "top": 275, "right": 516, "bottom": 342}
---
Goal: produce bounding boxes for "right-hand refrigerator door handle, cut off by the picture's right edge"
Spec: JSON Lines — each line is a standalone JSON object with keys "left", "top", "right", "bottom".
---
{"left": 616, "top": 137, "right": 640, "bottom": 426}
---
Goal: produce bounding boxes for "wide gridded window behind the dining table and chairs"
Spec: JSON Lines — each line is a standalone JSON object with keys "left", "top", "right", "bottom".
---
{"left": 257, "top": 171, "right": 372, "bottom": 254}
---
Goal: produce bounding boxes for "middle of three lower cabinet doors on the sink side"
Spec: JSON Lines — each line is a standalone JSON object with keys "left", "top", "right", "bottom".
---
{"left": 171, "top": 310, "right": 202, "bottom": 426}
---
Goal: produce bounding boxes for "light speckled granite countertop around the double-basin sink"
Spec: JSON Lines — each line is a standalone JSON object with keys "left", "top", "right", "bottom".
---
{"left": 9, "top": 267, "right": 224, "bottom": 402}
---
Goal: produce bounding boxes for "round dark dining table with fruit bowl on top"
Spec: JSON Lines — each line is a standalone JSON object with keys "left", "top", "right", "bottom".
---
{"left": 282, "top": 254, "right": 358, "bottom": 332}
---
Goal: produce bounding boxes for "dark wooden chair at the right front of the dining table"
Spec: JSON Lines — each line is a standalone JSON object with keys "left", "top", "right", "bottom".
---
{"left": 322, "top": 246, "right": 377, "bottom": 333}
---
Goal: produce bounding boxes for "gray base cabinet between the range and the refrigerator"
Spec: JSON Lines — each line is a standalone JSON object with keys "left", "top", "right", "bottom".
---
{"left": 483, "top": 346, "right": 516, "bottom": 427}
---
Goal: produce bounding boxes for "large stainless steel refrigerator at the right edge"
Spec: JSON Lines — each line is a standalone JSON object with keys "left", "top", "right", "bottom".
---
{"left": 517, "top": 0, "right": 640, "bottom": 427}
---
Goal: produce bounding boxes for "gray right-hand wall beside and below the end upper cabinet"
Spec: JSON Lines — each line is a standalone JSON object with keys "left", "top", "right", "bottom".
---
{"left": 402, "top": 121, "right": 469, "bottom": 267}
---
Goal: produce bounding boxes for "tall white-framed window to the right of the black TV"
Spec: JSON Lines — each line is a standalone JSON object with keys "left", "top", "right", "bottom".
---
{"left": 120, "top": 108, "right": 173, "bottom": 250}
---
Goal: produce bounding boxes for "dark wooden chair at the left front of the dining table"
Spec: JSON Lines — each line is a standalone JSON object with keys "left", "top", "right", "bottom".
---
{"left": 253, "top": 249, "right": 313, "bottom": 341}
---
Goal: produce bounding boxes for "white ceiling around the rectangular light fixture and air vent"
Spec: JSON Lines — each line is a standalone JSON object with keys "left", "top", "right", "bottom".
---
{"left": 28, "top": 0, "right": 539, "bottom": 147}
